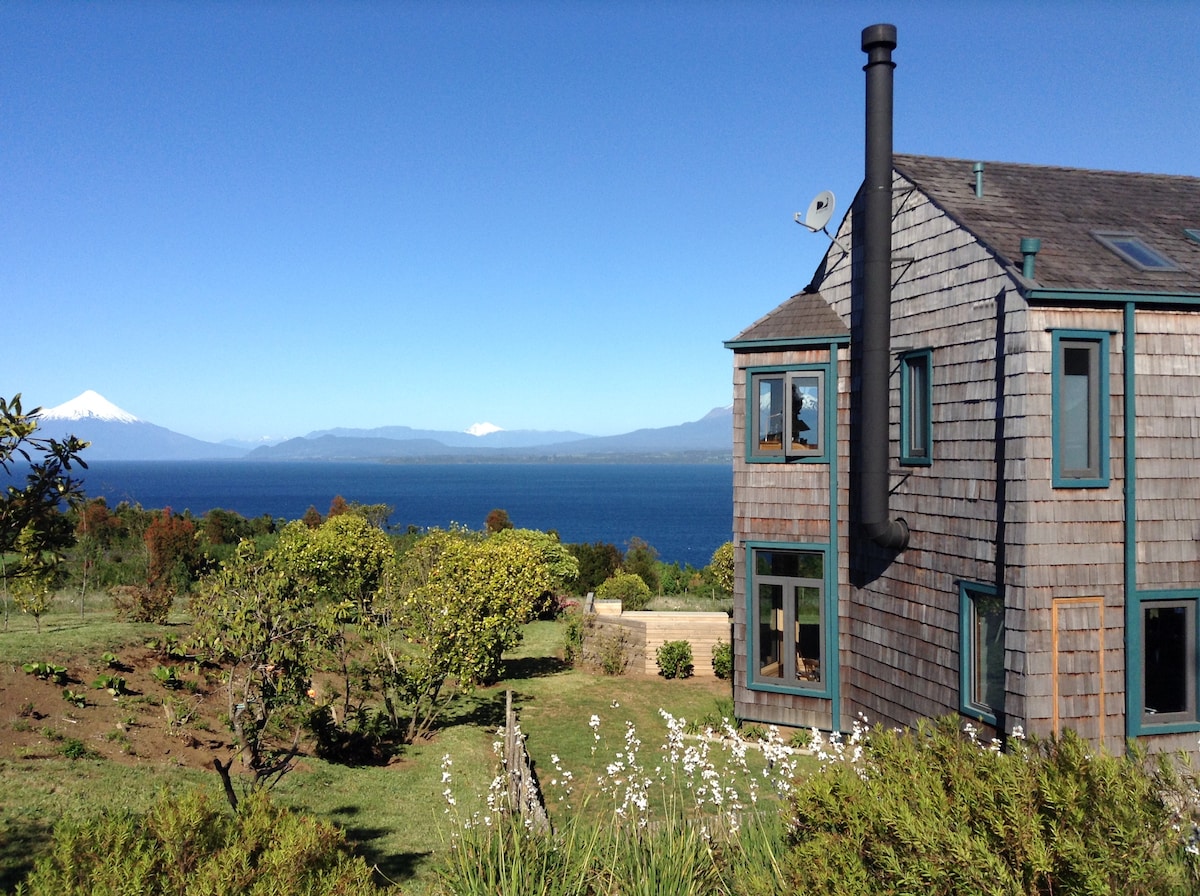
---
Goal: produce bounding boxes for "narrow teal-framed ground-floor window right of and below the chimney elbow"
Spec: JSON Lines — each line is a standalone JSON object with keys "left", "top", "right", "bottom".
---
{"left": 959, "top": 582, "right": 1004, "bottom": 724}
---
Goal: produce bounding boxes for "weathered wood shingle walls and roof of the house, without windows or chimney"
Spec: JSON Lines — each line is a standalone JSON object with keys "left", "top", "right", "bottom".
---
{"left": 727, "top": 156, "right": 1200, "bottom": 750}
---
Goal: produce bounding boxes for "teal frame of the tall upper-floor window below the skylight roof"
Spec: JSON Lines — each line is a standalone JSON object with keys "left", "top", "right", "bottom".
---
{"left": 1050, "top": 330, "right": 1111, "bottom": 488}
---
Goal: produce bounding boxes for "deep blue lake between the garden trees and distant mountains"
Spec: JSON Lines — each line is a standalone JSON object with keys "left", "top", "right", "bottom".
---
{"left": 83, "top": 461, "right": 733, "bottom": 566}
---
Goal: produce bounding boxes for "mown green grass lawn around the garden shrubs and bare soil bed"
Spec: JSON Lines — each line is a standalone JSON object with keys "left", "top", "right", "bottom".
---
{"left": 0, "top": 613, "right": 796, "bottom": 894}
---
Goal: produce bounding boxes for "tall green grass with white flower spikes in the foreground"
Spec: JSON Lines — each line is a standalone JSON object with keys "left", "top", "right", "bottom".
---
{"left": 437, "top": 711, "right": 798, "bottom": 896}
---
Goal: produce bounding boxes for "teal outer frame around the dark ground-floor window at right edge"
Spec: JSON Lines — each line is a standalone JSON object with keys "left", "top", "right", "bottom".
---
{"left": 1126, "top": 590, "right": 1200, "bottom": 736}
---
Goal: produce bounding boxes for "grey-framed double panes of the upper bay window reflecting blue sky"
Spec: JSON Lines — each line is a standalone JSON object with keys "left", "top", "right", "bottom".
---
{"left": 746, "top": 371, "right": 826, "bottom": 459}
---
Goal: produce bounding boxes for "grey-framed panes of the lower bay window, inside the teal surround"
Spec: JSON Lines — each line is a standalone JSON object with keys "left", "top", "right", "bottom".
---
{"left": 748, "top": 548, "right": 828, "bottom": 690}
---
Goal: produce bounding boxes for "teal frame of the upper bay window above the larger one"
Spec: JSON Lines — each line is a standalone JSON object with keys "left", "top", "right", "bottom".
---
{"left": 745, "top": 365, "right": 835, "bottom": 463}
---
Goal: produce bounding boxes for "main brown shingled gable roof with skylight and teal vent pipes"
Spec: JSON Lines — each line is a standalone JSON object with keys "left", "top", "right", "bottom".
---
{"left": 893, "top": 154, "right": 1200, "bottom": 294}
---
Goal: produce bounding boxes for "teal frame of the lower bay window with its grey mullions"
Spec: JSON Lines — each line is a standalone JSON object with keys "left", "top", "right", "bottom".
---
{"left": 745, "top": 542, "right": 838, "bottom": 699}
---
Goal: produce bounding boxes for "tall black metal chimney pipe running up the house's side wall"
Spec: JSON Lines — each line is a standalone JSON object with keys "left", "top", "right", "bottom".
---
{"left": 859, "top": 25, "right": 908, "bottom": 551}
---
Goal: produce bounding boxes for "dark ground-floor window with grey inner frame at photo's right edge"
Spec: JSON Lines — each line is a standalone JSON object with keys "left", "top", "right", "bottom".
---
{"left": 1141, "top": 600, "right": 1196, "bottom": 724}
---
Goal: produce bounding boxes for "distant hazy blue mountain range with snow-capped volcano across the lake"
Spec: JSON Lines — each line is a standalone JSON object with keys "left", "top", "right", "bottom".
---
{"left": 38, "top": 390, "right": 733, "bottom": 463}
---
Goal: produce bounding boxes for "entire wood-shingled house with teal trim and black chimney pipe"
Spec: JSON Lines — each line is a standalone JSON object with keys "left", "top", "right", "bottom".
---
{"left": 726, "top": 25, "right": 1200, "bottom": 751}
